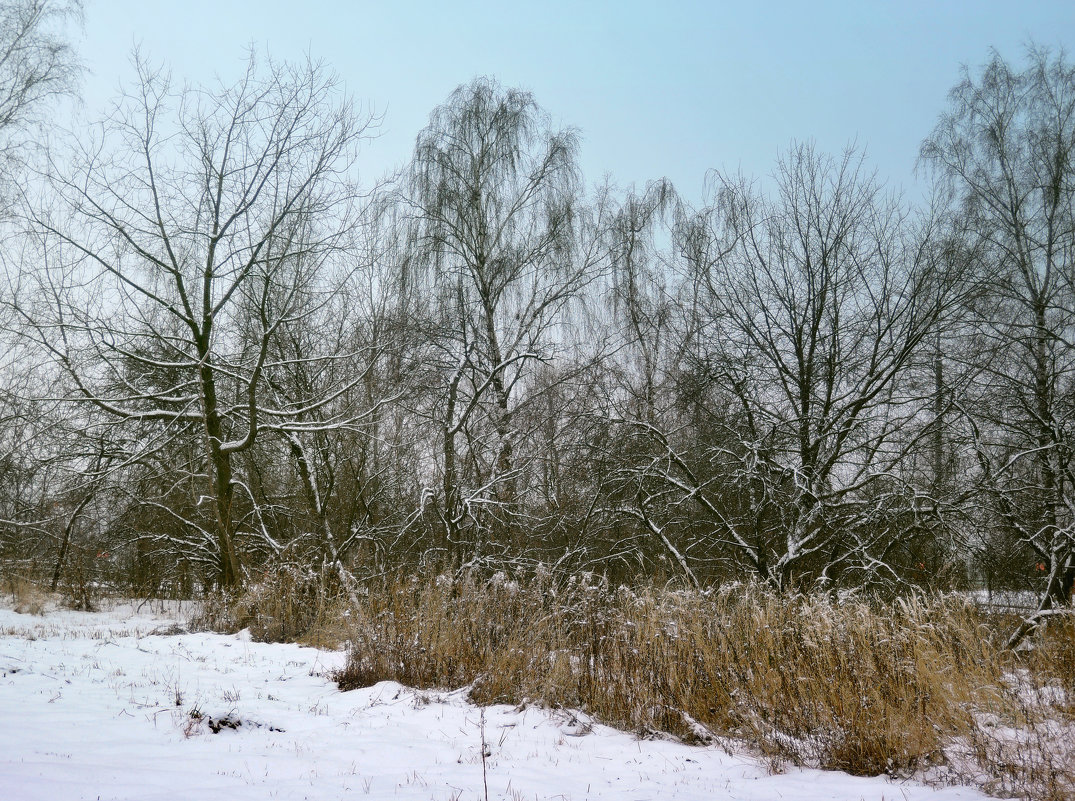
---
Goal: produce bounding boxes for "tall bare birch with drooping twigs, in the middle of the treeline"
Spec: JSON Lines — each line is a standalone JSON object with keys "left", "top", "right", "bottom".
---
{"left": 407, "top": 78, "right": 598, "bottom": 545}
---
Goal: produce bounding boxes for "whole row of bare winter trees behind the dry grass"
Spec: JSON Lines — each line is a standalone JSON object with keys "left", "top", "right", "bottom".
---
{"left": 0, "top": 2, "right": 1075, "bottom": 623}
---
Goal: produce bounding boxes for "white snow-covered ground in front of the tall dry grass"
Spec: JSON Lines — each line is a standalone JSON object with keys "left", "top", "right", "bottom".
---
{"left": 0, "top": 604, "right": 985, "bottom": 801}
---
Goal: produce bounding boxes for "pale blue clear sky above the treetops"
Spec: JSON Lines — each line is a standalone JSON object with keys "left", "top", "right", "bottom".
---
{"left": 80, "top": 0, "right": 1075, "bottom": 206}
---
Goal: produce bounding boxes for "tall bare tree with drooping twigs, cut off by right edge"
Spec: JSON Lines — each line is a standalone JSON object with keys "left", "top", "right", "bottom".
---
{"left": 921, "top": 43, "right": 1075, "bottom": 632}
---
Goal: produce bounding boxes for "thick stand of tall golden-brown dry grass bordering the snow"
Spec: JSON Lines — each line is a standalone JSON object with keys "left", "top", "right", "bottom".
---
{"left": 324, "top": 572, "right": 1075, "bottom": 801}
